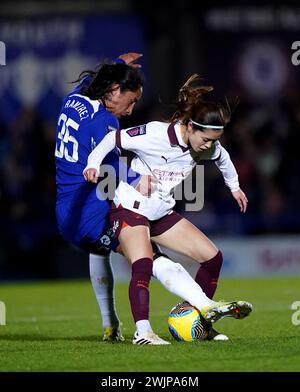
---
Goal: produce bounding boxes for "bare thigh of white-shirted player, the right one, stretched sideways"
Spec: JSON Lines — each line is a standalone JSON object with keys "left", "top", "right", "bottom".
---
{"left": 151, "top": 218, "right": 218, "bottom": 263}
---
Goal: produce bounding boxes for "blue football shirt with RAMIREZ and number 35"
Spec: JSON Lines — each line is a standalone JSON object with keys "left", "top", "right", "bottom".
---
{"left": 55, "top": 77, "right": 119, "bottom": 197}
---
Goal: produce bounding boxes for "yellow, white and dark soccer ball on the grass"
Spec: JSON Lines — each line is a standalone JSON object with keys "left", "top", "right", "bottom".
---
{"left": 168, "top": 301, "right": 211, "bottom": 342}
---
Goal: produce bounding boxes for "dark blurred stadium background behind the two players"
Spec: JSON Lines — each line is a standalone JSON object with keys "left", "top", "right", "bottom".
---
{"left": 0, "top": 0, "right": 300, "bottom": 281}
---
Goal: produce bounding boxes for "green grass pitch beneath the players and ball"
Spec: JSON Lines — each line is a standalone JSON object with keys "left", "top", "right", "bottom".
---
{"left": 0, "top": 277, "right": 300, "bottom": 372}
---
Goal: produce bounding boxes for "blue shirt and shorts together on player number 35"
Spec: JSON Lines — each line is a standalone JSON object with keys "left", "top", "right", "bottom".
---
{"left": 55, "top": 77, "right": 134, "bottom": 246}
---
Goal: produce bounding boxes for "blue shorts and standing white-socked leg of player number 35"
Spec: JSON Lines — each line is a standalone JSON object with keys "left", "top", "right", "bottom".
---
{"left": 56, "top": 191, "right": 123, "bottom": 341}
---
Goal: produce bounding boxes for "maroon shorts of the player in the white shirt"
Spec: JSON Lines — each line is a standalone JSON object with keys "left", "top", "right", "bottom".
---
{"left": 109, "top": 203, "right": 183, "bottom": 239}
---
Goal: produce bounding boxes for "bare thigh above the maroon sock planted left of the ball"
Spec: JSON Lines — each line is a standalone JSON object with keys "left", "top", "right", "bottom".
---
{"left": 118, "top": 226, "right": 153, "bottom": 264}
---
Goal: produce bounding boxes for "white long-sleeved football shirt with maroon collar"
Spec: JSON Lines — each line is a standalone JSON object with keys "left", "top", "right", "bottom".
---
{"left": 85, "top": 121, "right": 239, "bottom": 220}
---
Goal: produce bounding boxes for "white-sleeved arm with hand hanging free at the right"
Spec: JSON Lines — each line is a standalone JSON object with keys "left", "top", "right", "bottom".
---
{"left": 215, "top": 142, "right": 248, "bottom": 212}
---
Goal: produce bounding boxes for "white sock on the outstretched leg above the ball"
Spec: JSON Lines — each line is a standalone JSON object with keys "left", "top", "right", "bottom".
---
{"left": 152, "top": 256, "right": 214, "bottom": 310}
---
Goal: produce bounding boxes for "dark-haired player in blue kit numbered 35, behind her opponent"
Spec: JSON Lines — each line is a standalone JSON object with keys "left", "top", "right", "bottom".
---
{"left": 55, "top": 53, "right": 149, "bottom": 340}
